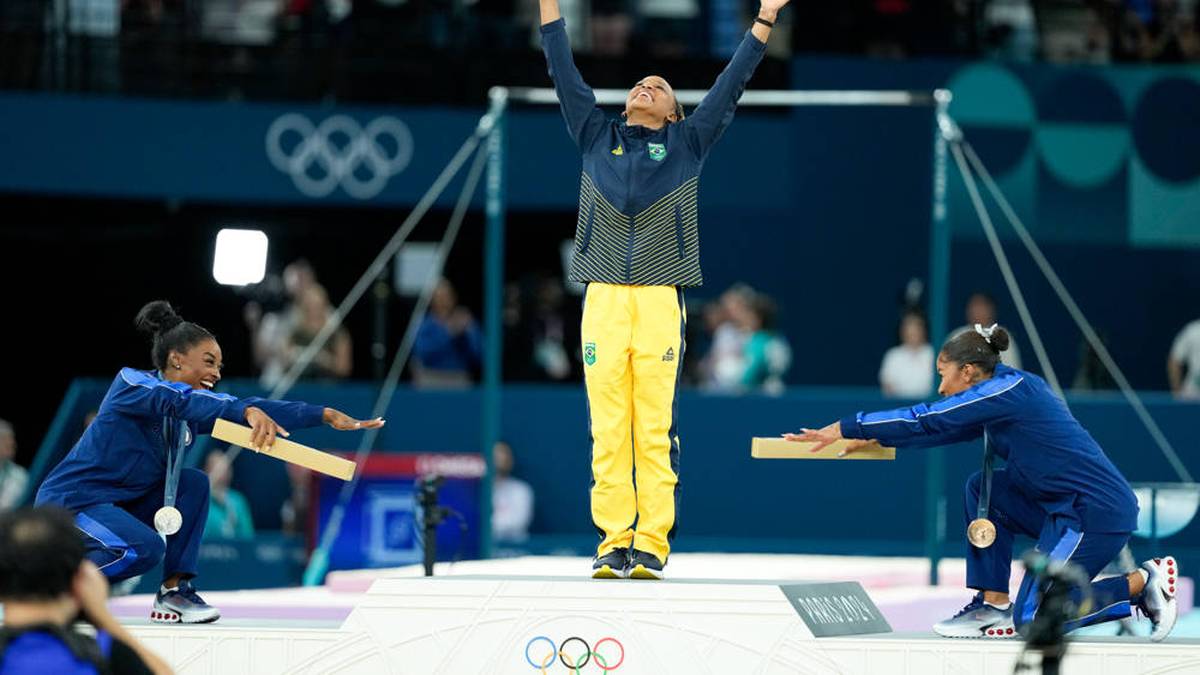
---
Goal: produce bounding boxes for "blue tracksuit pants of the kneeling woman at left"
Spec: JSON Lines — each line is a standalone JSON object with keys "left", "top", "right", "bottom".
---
{"left": 76, "top": 468, "right": 209, "bottom": 581}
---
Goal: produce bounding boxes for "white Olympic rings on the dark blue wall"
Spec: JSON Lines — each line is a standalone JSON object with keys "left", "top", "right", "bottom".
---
{"left": 266, "top": 113, "right": 413, "bottom": 199}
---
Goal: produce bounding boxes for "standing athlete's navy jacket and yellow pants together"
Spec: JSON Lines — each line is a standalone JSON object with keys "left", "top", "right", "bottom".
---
{"left": 541, "top": 19, "right": 766, "bottom": 562}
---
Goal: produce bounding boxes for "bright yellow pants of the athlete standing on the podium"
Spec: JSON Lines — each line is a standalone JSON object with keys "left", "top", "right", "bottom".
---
{"left": 583, "top": 283, "right": 686, "bottom": 562}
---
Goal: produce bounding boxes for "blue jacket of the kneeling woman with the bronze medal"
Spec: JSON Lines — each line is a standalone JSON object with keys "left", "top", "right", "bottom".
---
{"left": 841, "top": 364, "right": 1138, "bottom": 532}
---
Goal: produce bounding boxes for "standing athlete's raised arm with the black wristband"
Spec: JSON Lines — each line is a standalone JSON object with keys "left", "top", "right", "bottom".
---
{"left": 684, "top": 0, "right": 788, "bottom": 157}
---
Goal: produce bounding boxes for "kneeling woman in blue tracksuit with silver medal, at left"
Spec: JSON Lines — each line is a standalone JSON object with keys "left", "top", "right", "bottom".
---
{"left": 37, "top": 300, "right": 383, "bottom": 623}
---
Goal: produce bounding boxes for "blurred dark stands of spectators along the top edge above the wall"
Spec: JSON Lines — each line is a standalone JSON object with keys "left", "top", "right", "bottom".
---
{"left": 0, "top": 0, "right": 1200, "bottom": 97}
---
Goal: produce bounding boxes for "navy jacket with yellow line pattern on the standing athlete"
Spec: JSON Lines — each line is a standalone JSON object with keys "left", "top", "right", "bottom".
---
{"left": 541, "top": 19, "right": 767, "bottom": 286}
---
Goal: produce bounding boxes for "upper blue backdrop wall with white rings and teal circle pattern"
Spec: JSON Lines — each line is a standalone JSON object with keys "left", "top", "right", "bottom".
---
{"left": 0, "top": 59, "right": 1200, "bottom": 389}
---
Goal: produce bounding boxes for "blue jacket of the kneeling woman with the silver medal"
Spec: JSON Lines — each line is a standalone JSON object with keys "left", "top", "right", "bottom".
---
{"left": 37, "top": 368, "right": 325, "bottom": 512}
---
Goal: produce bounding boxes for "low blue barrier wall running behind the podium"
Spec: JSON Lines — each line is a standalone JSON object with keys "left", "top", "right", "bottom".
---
{"left": 35, "top": 380, "right": 1200, "bottom": 563}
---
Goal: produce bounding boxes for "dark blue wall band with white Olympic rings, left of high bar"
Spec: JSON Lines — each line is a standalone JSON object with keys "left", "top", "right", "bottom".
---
{"left": 0, "top": 94, "right": 482, "bottom": 205}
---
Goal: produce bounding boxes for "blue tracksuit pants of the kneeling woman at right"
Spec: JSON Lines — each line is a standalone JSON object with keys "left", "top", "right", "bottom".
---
{"left": 964, "top": 468, "right": 1130, "bottom": 631}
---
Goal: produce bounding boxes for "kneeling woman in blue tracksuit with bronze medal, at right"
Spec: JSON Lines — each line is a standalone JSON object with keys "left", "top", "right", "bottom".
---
{"left": 785, "top": 324, "right": 1178, "bottom": 641}
